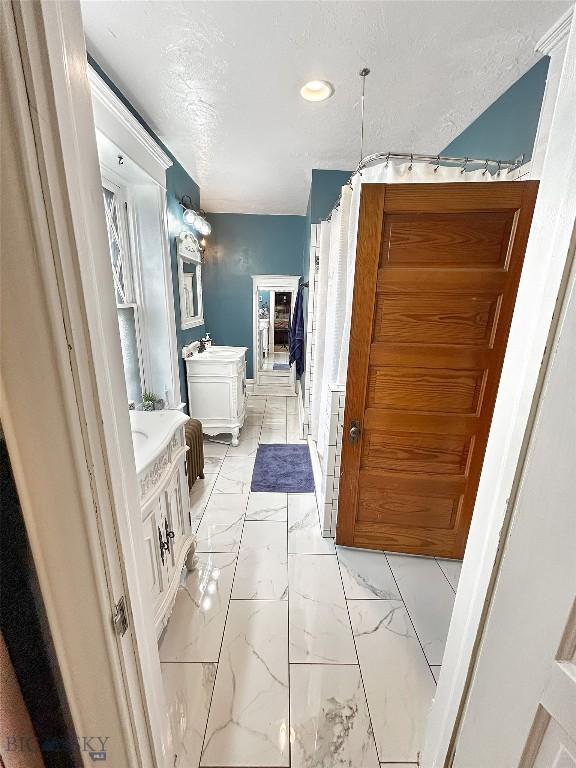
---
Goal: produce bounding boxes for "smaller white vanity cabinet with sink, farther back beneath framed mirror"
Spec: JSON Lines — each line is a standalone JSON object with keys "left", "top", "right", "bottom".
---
{"left": 182, "top": 343, "right": 247, "bottom": 445}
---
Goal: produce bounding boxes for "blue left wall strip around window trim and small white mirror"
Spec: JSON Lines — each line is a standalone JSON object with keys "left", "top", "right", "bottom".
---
{"left": 88, "top": 54, "right": 205, "bottom": 403}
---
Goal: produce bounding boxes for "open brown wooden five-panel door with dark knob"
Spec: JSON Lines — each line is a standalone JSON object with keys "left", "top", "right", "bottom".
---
{"left": 336, "top": 181, "right": 538, "bottom": 558}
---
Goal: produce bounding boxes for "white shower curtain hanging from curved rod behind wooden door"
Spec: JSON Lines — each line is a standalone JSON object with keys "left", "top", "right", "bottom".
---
{"left": 311, "top": 161, "right": 506, "bottom": 456}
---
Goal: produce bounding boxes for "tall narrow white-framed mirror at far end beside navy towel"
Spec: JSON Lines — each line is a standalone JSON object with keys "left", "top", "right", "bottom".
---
{"left": 252, "top": 275, "right": 300, "bottom": 396}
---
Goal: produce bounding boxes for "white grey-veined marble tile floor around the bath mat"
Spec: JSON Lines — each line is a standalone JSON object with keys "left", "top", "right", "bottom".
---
{"left": 160, "top": 396, "right": 460, "bottom": 768}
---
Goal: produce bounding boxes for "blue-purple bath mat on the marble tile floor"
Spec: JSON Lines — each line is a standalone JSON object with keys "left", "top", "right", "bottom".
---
{"left": 251, "top": 443, "right": 314, "bottom": 493}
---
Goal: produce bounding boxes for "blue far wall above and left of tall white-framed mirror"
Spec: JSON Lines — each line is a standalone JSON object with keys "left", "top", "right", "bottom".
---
{"left": 202, "top": 213, "right": 306, "bottom": 378}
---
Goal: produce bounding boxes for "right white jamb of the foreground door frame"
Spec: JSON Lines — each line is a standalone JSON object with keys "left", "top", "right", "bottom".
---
{"left": 421, "top": 9, "right": 576, "bottom": 768}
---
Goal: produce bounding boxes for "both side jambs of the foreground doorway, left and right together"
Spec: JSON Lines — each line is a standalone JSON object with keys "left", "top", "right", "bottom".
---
{"left": 0, "top": 0, "right": 576, "bottom": 768}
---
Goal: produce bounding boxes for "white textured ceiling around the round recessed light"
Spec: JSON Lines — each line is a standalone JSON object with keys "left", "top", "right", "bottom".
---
{"left": 82, "top": 0, "right": 569, "bottom": 214}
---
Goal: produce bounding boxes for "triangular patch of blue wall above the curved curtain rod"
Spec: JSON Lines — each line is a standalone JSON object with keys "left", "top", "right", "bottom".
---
{"left": 442, "top": 56, "right": 550, "bottom": 165}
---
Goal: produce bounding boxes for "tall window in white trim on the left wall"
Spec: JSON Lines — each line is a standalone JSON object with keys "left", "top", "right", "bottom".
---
{"left": 102, "top": 181, "right": 145, "bottom": 404}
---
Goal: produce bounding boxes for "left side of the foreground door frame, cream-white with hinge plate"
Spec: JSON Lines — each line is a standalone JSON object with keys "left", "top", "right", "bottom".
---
{"left": 0, "top": 0, "right": 174, "bottom": 768}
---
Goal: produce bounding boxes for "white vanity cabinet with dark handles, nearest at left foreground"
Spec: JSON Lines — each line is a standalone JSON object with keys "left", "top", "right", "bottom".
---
{"left": 130, "top": 410, "right": 194, "bottom": 637}
